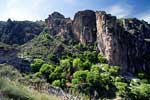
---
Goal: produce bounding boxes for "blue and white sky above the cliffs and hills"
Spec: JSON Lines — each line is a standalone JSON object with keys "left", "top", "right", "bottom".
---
{"left": 0, "top": 0, "right": 150, "bottom": 22}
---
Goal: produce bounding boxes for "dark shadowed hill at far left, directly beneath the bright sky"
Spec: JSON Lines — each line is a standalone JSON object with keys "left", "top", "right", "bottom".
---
{"left": 0, "top": 19, "right": 43, "bottom": 45}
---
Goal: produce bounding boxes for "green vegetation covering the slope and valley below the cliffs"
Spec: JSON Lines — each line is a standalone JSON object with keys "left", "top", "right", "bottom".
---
{"left": 0, "top": 24, "right": 150, "bottom": 100}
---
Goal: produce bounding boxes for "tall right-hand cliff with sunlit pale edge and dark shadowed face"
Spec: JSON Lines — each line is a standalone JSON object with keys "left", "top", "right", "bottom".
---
{"left": 96, "top": 12, "right": 150, "bottom": 72}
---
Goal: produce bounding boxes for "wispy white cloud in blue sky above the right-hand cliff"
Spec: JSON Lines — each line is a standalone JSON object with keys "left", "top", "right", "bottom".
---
{"left": 106, "top": 4, "right": 132, "bottom": 18}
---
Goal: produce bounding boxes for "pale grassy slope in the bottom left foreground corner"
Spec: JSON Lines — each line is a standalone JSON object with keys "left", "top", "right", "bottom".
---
{"left": 0, "top": 64, "right": 61, "bottom": 100}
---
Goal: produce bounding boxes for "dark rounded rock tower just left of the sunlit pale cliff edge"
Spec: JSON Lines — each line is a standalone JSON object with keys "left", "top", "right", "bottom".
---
{"left": 72, "top": 10, "right": 96, "bottom": 43}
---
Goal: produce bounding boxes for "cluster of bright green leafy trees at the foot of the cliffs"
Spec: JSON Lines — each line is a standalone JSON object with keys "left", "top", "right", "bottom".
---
{"left": 31, "top": 45, "right": 150, "bottom": 100}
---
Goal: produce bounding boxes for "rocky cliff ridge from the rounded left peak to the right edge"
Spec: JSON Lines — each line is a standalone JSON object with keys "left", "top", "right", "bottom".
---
{"left": 47, "top": 10, "right": 150, "bottom": 72}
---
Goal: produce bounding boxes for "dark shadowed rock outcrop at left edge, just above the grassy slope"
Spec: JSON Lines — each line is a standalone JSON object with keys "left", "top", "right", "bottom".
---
{"left": 0, "top": 43, "right": 31, "bottom": 72}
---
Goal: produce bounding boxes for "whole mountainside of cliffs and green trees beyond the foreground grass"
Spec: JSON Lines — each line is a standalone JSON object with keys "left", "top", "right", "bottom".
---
{"left": 0, "top": 10, "right": 150, "bottom": 100}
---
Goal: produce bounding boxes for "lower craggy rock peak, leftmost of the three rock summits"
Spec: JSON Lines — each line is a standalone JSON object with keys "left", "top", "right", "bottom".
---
{"left": 45, "top": 12, "right": 72, "bottom": 35}
